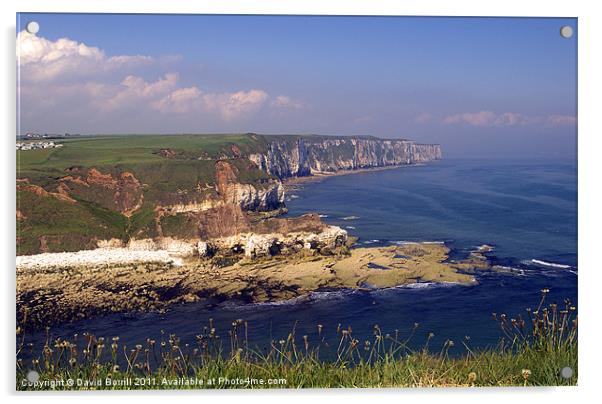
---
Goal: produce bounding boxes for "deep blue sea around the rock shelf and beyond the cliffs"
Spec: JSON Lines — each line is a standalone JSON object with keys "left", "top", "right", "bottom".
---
{"left": 21, "top": 160, "right": 578, "bottom": 352}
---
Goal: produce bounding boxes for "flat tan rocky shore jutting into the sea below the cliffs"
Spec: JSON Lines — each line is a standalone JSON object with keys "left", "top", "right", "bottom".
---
{"left": 17, "top": 238, "right": 491, "bottom": 330}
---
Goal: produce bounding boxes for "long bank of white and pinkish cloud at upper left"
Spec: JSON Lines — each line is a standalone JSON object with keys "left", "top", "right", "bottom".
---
{"left": 17, "top": 31, "right": 306, "bottom": 127}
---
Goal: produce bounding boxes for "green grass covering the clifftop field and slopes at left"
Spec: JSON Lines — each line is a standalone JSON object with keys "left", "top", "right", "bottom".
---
{"left": 17, "top": 134, "right": 271, "bottom": 254}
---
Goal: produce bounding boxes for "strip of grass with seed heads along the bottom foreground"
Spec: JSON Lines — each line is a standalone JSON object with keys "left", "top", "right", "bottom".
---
{"left": 16, "top": 289, "right": 577, "bottom": 390}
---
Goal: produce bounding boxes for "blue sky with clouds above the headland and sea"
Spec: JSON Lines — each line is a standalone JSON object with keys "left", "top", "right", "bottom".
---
{"left": 16, "top": 13, "right": 577, "bottom": 159}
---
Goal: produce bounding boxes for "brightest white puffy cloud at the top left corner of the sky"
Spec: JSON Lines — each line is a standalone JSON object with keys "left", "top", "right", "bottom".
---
{"left": 17, "top": 31, "right": 153, "bottom": 82}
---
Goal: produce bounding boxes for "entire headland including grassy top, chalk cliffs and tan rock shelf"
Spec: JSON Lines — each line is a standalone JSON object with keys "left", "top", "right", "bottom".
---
{"left": 17, "top": 134, "right": 464, "bottom": 328}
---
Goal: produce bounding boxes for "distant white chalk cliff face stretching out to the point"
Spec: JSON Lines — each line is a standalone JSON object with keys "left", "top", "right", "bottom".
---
{"left": 249, "top": 137, "right": 441, "bottom": 178}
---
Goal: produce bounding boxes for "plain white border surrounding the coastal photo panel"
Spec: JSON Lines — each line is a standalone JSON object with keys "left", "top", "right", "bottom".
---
{"left": 0, "top": 0, "right": 602, "bottom": 404}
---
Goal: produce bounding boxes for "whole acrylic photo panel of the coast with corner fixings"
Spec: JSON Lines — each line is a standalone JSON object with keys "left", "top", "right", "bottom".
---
{"left": 16, "top": 13, "right": 578, "bottom": 390}
